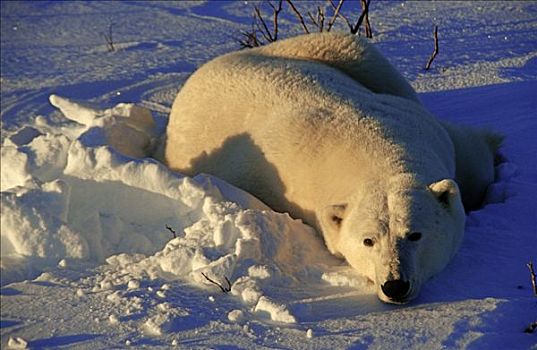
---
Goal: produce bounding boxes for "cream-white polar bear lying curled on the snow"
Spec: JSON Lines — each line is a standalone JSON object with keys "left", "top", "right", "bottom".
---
{"left": 162, "top": 33, "right": 496, "bottom": 303}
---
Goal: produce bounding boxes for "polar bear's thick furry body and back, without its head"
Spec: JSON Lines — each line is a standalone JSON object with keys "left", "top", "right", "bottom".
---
{"left": 165, "top": 35, "right": 454, "bottom": 223}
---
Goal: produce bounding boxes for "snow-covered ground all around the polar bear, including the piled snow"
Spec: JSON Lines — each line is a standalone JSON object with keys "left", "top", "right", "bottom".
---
{"left": 0, "top": 0, "right": 537, "bottom": 349}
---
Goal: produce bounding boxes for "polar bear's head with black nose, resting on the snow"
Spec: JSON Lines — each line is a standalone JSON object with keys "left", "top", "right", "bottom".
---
{"left": 320, "top": 179, "right": 465, "bottom": 303}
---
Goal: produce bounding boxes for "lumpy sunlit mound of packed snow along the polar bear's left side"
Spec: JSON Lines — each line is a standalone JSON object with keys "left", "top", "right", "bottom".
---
{"left": 1, "top": 96, "right": 369, "bottom": 322}
